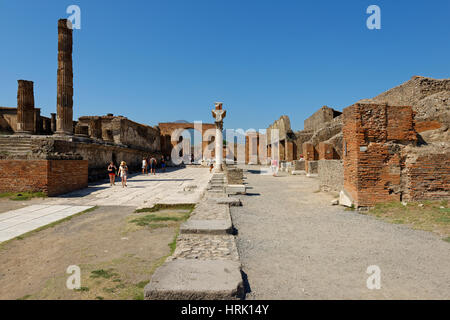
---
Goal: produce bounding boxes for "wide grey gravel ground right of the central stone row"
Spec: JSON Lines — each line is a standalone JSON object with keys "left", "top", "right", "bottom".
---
{"left": 231, "top": 167, "right": 450, "bottom": 299}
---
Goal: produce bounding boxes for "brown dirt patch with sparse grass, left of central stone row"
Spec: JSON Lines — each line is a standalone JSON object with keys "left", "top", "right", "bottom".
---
{"left": 0, "top": 205, "right": 189, "bottom": 300}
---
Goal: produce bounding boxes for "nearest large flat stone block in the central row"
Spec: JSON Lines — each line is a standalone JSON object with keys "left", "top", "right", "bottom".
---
{"left": 144, "top": 259, "right": 244, "bottom": 300}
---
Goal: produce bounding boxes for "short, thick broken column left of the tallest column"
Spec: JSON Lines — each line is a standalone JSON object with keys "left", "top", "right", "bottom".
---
{"left": 16, "top": 80, "right": 34, "bottom": 134}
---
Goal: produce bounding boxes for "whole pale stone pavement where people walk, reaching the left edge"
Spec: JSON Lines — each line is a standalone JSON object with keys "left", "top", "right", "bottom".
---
{"left": 0, "top": 167, "right": 211, "bottom": 242}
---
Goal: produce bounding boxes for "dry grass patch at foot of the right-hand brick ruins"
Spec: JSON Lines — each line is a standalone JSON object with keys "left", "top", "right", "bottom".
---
{"left": 364, "top": 200, "right": 450, "bottom": 242}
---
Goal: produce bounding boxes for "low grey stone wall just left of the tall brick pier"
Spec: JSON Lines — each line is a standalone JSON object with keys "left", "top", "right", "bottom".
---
{"left": 318, "top": 160, "right": 344, "bottom": 192}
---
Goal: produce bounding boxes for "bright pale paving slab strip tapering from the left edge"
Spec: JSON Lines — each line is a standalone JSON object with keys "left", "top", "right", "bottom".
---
{"left": 0, "top": 205, "right": 93, "bottom": 242}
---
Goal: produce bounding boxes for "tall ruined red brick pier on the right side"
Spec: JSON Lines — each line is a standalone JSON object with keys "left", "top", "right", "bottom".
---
{"left": 343, "top": 104, "right": 417, "bottom": 206}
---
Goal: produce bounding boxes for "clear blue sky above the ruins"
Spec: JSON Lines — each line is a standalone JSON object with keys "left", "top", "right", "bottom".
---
{"left": 0, "top": 0, "right": 450, "bottom": 130}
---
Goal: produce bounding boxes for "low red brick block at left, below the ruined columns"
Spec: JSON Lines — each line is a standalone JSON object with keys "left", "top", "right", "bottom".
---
{"left": 0, "top": 160, "right": 88, "bottom": 196}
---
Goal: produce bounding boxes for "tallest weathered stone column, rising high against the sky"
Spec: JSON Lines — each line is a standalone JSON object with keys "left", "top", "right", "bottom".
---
{"left": 56, "top": 19, "right": 73, "bottom": 135}
